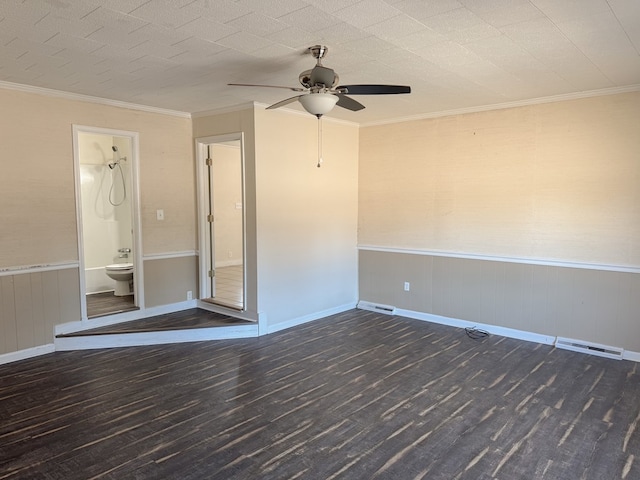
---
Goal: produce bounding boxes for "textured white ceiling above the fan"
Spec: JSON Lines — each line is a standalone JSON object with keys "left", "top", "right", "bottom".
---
{"left": 0, "top": 0, "right": 640, "bottom": 123}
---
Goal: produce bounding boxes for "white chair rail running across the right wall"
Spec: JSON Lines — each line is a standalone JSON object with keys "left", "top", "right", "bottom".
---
{"left": 358, "top": 245, "right": 640, "bottom": 273}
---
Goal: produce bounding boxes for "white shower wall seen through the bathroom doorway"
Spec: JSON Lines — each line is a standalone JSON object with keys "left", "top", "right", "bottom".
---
{"left": 78, "top": 133, "right": 133, "bottom": 293}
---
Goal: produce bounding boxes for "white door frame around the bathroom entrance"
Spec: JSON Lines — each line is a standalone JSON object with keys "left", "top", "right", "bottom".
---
{"left": 73, "top": 125, "right": 144, "bottom": 322}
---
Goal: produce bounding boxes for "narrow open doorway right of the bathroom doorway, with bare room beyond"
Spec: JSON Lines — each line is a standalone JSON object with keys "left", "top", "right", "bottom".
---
{"left": 196, "top": 133, "right": 246, "bottom": 312}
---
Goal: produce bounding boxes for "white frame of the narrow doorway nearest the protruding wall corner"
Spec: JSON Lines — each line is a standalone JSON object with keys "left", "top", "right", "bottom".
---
{"left": 195, "top": 132, "right": 247, "bottom": 312}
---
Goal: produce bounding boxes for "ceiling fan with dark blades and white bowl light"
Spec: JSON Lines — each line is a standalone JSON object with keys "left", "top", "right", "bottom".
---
{"left": 229, "top": 45, "right": 411, "bottom": 119}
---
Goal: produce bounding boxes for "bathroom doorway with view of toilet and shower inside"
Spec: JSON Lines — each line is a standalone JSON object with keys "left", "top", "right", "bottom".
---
{"left": 73, "top": 126, "right": 142, "bottom": 320}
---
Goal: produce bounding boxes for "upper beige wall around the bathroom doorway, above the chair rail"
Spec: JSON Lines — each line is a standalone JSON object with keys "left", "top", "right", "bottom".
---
{"left": 0, "top": 89, "right": 196, "bottom": 267}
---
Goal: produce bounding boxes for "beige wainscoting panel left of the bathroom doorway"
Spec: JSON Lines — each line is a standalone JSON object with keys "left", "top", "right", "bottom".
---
{"left": 0, "top": 268, "right": 80, "bottom": 354}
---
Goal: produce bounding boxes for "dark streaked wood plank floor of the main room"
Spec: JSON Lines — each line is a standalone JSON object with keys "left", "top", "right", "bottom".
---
{"left": 0, "top": 310, "right": 640, "bottom": 480}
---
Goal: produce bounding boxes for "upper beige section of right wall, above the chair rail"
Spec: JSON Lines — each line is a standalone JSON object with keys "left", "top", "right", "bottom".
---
{"left": 359, "top": 92, "right": 640, "bottom": 266}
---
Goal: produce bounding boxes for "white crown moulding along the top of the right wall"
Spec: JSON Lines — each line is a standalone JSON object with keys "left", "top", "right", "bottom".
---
{"left": 360, "top": 84, "right": 640, "bottom": 127}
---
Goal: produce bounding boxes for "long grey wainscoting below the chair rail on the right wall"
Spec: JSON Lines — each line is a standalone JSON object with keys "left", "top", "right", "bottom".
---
{"left": 359, "top": 249, "right": 640, "bottom": 352}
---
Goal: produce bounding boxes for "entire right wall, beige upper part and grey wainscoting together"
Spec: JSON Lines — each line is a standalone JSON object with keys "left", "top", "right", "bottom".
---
{"left": 358, "top": 93, "right": 640, "bottom": 352}
